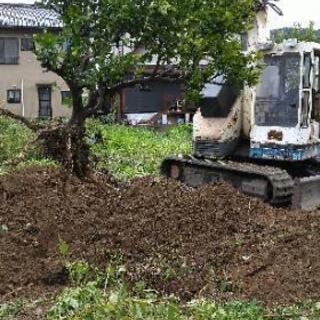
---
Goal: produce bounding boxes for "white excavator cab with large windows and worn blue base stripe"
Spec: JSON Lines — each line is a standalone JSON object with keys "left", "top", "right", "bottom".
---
{"left": 250, "top": 41, "right": 320, "bottom": 161}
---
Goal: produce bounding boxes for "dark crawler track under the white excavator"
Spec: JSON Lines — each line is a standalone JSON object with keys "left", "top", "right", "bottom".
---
{"left": 161, "top": 157, "right": 295, "bottom": 206}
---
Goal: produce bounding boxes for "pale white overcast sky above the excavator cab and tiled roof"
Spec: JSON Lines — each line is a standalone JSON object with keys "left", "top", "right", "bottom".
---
{"left": 0, "top": 0, "right": 320, "bottom": 29}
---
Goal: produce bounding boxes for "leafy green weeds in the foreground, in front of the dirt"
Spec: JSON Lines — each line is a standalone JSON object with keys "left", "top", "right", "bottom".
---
{"left": 43, "top": 261, "right": 320, "bottom": 320}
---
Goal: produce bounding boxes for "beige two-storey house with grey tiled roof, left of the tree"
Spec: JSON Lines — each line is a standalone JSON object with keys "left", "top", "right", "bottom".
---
{"left": 0, "top": 3, "right": 71, "bottom": 119}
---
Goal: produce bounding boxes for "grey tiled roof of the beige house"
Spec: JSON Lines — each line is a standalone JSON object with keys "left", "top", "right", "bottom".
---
{"left": 0, "top": 3, "right": 61, "bottom": 28}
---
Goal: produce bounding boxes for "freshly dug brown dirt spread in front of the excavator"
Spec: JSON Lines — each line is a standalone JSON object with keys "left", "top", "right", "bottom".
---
{"left": 0, "top": 168, "right": 320, "bottom": 304}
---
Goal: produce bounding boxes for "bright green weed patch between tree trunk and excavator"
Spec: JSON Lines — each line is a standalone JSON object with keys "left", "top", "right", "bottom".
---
{"left": 87, "top": 121, "right": 192, "bottom": 179}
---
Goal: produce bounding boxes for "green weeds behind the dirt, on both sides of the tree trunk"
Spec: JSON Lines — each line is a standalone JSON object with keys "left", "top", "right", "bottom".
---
{"left": 0, "top": 116, "right": 192, "bottom": 179}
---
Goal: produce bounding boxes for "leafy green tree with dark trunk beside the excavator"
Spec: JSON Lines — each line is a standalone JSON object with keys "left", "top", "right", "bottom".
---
{"left": 1, "top": 0, "right": 268, "bottom": 176}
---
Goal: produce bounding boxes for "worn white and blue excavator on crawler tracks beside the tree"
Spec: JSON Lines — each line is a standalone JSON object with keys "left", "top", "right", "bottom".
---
{"left": 161, "top": 0, "right": 320, "bottom": 211}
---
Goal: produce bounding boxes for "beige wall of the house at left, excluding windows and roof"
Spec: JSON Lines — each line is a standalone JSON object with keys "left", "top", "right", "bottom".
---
{"left": 0, "top": 29, "right": 71, "bottom": 118}
